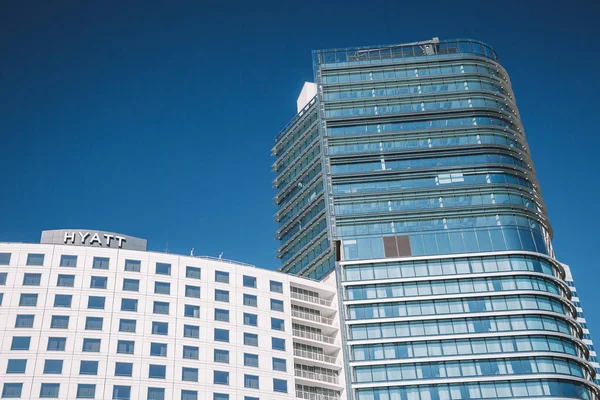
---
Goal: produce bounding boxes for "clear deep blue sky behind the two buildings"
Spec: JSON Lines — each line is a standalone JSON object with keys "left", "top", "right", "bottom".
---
{"left": 0, "top": 0, "right": 600, "bottom": 328}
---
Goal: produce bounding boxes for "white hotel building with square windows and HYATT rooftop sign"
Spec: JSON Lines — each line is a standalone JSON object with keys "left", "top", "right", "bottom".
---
{"left": 0, "top": 230, "right": 346, "bottom": 400}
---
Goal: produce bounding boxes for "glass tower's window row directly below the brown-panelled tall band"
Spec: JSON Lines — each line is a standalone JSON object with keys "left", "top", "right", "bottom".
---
{"left": 344, "top": 255, "right": 560, "bottom": 282}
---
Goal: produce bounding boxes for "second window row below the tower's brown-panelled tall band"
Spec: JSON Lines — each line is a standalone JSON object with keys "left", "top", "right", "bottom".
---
{"left": 346, "top": 276, "right": 566, "bottom": 300}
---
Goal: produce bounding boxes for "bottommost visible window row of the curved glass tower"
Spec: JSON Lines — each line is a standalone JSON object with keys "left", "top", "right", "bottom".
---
{"left": 356, "top": 379, "right": 596, "bottom": 400}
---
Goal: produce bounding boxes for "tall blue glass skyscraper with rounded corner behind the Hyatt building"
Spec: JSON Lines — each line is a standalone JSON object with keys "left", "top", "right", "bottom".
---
{"left": 273, "top": 38, "right": 600, "bottom": 400}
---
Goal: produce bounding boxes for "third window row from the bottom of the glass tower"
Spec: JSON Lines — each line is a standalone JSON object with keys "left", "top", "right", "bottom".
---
{"left": 352, "top": 335, "right": 585, "bottom": 361}
